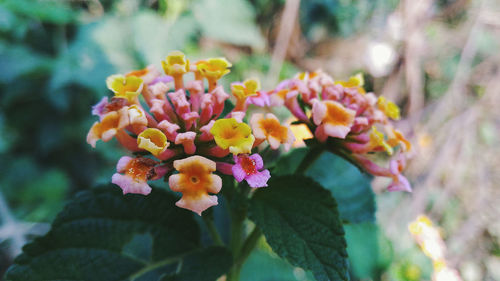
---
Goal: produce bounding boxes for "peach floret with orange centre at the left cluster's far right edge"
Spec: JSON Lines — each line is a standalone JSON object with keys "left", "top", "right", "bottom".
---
{"left": 250, "top": 113, "right": 295, "bottom": 151}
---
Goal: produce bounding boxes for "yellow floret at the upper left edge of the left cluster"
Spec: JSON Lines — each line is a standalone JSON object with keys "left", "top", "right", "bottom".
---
{"left": 106, "top": 74, "right": 143, "bottom": 102}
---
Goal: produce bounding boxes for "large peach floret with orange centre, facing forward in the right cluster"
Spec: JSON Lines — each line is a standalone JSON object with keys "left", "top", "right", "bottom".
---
{"left": 312, "top": 100, "right": 356, "bottom": 141}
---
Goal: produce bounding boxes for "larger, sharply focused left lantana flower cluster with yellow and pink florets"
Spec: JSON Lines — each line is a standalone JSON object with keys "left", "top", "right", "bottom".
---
{"left": 87, "top": 51, "right": 295, "bottom": 214}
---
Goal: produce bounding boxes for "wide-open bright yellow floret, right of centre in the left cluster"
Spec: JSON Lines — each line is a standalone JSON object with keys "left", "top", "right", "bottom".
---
{"left": 210, "top": 118, "right": 255, "bottom": 154}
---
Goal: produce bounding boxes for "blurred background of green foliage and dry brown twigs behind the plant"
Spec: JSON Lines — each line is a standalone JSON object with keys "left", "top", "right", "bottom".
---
{"left": 0, "top": 0, "right": 500, "bottom": 281}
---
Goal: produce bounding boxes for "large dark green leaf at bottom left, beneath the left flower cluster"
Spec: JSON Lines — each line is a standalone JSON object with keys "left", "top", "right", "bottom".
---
{"left": 6, "top": 186, "right": 200, "bottom": 281}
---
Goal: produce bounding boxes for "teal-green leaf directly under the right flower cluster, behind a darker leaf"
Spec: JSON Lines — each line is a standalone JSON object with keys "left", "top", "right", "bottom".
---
{"left": 305, "top": 152, "right": 376, "bottom": 223}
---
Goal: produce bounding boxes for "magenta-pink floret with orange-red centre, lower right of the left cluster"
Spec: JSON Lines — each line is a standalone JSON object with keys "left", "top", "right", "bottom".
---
{"left": 232, "top": 154, "right": 271, "bottom": 188}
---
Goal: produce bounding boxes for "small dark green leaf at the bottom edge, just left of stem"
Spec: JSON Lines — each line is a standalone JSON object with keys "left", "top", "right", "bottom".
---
{"left": 161, "top": 246, "right": 233, "bottom": 281}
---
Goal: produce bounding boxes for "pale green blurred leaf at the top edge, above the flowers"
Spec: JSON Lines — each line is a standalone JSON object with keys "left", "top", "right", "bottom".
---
{"left": 194, "top": 0, "right": 265, "bottom": 49}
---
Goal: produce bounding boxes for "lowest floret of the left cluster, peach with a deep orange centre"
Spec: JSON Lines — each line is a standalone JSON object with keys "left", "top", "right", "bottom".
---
{"left": 168, "top": 155, "right": 222, "bottom": 216}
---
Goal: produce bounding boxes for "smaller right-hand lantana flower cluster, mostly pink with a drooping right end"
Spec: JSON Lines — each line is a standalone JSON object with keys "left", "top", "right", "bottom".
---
{"left": 262, "top": 71, "right": 411, "bottom": 192}
